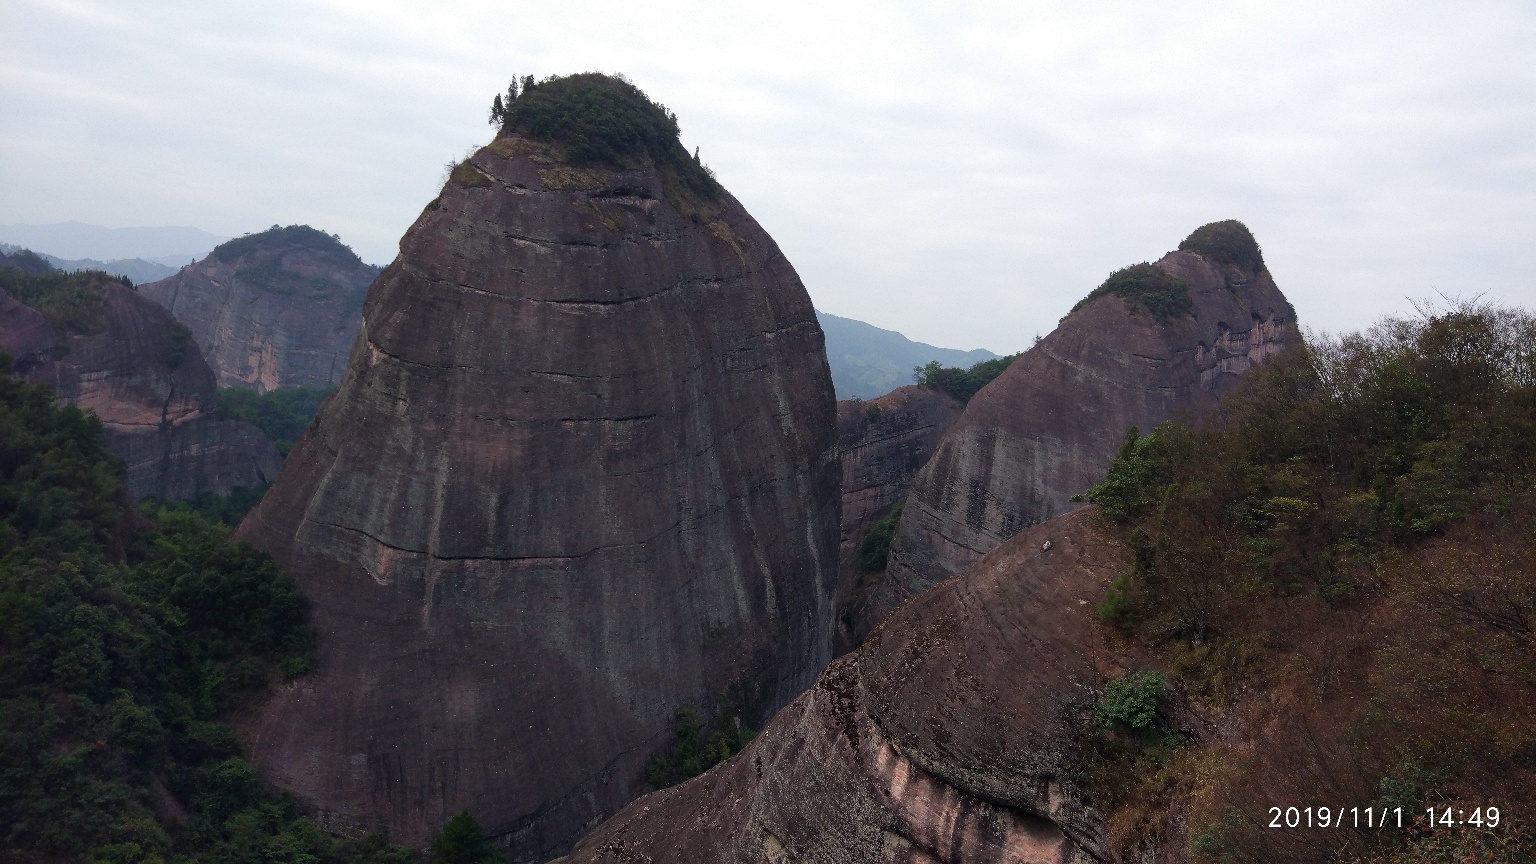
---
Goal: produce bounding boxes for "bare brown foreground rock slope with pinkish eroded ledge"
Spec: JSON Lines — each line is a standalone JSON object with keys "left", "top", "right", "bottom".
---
{"left": 562, "top": 512, "right": 1129, "bottom": 864}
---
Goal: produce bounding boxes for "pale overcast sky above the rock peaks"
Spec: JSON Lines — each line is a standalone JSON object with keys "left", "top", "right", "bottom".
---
{"left": 0, "top": 0, "right": 1536, "bottom": 352}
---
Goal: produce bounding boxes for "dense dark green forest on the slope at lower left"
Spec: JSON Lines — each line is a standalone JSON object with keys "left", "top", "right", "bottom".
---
{"left": 0, "top": 360, "right": 415, "bottom": 864}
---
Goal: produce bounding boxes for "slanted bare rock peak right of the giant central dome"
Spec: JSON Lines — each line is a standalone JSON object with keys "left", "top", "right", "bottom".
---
{"left": 866, "top": 223, "right": 1301, "bottom": 636}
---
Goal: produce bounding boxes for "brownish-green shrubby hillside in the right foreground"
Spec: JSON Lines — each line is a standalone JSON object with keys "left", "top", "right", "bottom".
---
{"left": 1083, "top": 304, "right": 1536, "bottom": 864}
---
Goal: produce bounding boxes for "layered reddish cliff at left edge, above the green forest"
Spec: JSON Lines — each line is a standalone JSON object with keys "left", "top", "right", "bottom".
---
{"left": 0, "top": 274, "right": 281, "bottom": 500}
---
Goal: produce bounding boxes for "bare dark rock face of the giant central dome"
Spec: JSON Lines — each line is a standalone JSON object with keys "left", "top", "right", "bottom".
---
{"left": 240, "top": 80, "right": 839, "bottom": 859}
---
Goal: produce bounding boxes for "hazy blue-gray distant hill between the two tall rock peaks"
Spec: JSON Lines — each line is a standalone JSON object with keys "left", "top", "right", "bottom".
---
{"left": 816, "top": 311, "right": 997, "bottom": 400}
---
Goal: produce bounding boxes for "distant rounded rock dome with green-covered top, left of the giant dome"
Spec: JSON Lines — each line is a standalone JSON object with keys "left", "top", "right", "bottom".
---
{"left": 140, "top": 224, "right": 379, "bottom": 394}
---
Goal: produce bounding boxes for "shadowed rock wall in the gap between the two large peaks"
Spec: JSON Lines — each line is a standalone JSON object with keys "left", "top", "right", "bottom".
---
{"left": 833, "top": 384, "right": 963, "bottom": 655}
